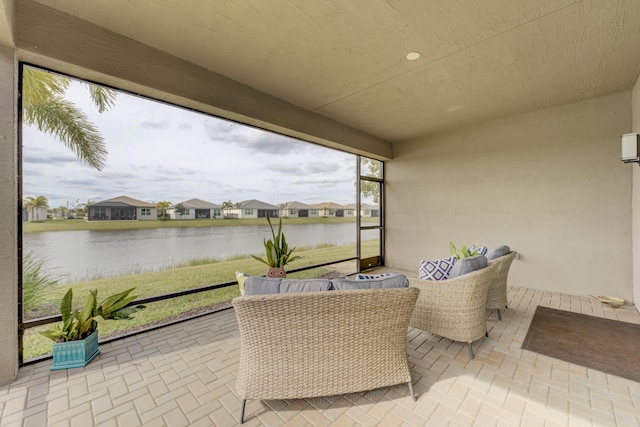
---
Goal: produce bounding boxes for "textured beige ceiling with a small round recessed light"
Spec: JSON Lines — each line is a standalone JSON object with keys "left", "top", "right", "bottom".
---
{"left": 20, "top": 0, "right": 640, "bottom": 142}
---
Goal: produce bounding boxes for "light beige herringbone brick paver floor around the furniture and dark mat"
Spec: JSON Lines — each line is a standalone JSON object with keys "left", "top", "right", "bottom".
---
{"left": 0, "top": 287, "right": 640, "bottom": 427}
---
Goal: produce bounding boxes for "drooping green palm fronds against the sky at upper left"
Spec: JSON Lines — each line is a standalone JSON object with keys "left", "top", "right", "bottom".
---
{"left": 22, "top": 67, "right": 117, "bottom": 170}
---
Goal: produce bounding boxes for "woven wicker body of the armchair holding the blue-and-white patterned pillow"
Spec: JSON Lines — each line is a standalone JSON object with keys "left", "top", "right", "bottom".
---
{"left": 409, "top": 263, "right": 498, "bottom": 359}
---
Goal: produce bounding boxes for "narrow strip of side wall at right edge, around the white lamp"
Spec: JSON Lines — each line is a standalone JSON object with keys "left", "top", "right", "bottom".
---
{"left": 630, "top": 76, "right": 640, "bottom": 308}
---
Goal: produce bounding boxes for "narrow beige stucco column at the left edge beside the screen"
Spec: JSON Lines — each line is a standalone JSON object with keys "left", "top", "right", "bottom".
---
{"left": 0, "top": 45, "right": 18, "bottom": 384}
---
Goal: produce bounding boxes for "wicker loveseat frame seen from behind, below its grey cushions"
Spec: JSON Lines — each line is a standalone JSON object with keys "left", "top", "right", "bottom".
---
{"left": 232, "top": 288, "right": 419, "bottom": 423}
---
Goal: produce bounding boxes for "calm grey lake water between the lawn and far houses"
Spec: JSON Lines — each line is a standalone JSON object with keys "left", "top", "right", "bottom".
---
{"left": 23, "top": 223, "right": 368, "bottom": 282}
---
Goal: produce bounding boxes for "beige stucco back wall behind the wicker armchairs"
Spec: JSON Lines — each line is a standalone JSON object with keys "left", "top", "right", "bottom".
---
{"left": 385, "top": 92, "right": 633, "bottom": 300}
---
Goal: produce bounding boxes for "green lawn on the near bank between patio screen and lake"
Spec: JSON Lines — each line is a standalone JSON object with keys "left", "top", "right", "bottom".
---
{"left": 23, "top": 241, "right": 378, "bottom": 360}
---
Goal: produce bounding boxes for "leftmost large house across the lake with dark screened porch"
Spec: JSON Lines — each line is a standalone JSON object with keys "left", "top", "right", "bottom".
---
{"left": 87, "top": 196, "right": 158, "bottom": 221}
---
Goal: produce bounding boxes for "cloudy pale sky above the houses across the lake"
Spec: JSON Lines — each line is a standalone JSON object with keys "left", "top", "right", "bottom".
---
{"left": 22, "top": 71, "right": 356, "bottom": 208}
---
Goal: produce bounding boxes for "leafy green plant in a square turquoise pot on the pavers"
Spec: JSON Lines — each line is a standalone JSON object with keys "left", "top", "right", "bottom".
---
{"left": 40, "top": 288, "right": 145, "bottom": 370}
